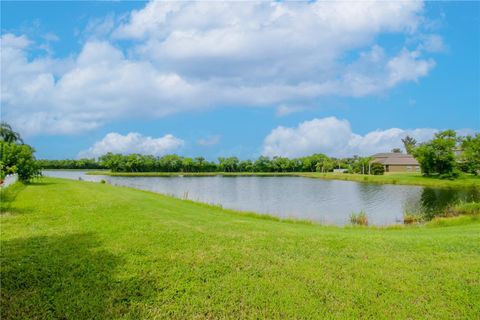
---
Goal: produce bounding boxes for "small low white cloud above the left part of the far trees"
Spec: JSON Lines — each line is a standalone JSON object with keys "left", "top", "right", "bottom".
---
{"left": 78, "top": 132, "right": 185, "bottom": 158}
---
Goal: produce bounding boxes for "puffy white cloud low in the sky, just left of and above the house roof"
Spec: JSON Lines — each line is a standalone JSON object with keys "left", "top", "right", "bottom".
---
{"left": 262, "top": 117, "right": 438, "bottom": 157}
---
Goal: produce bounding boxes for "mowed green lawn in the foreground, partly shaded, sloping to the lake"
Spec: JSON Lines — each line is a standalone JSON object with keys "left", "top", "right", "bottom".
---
{"left": 0, "top": 178, "right": 480, "bottom": 319}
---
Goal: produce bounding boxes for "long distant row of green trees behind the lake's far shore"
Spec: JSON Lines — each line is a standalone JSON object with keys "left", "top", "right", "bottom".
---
{"left": 38, "top": 153, "right": 383, "bottom": 174}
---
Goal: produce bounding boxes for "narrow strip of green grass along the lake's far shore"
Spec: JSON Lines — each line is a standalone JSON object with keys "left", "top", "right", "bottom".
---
{"left": 88, "top": 171, "right": 480, "bottom": 188}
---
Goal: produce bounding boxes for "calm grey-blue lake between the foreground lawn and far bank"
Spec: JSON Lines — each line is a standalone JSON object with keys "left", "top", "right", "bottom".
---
{"left": 43, "top": 170, "right": 480, "bottom": 226}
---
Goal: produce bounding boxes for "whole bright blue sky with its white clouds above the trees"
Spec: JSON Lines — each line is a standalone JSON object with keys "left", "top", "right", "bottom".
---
{"left": 1, "top": 1, "right": 480, "bottom": 159}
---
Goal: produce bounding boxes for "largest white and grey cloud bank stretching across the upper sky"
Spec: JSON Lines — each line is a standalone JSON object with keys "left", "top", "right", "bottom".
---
{"left": 0, "top": 1, "right": 442, "bottom": 135}
